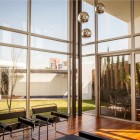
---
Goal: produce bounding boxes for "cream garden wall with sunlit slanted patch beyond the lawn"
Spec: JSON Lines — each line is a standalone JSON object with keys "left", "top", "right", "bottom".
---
{"left": 14, "top": 73, "right": 67, "bottom": 97}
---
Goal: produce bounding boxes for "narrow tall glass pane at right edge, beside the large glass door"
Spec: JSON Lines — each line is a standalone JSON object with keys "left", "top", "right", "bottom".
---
{"left": 135, "top": 54, "right": 140, "bottom": 121}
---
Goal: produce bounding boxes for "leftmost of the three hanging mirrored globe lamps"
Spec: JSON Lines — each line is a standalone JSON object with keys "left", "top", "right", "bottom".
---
{"left": 78, "top": 12, "right": 89, "bottom": 23}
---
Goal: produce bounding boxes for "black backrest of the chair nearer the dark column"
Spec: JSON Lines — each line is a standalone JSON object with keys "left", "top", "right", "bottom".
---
{"left": 31, "top": 104, "right": 57, "bottom": 115}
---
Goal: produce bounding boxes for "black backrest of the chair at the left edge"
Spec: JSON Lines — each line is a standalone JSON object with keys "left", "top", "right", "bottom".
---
{"left": 0, "top": 108, "right": 26, "bottom": 120}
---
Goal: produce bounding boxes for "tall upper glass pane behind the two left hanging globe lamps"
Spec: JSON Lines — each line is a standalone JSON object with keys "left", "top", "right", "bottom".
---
{"left": 82, "top": 0, "right": 95, "bottom": 43}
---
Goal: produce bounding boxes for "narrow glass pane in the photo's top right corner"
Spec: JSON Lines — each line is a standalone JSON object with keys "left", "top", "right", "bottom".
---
{"left": 134, "top": 0, "right": 140, "bottom": 33}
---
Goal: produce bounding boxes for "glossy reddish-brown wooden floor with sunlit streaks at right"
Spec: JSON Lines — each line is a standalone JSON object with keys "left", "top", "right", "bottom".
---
{"left": 0, "top": 114, "right": 140, "bottom": 140}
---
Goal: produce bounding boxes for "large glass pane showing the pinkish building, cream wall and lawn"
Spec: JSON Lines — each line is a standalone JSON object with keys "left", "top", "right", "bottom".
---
{"left": 30, "top": 51, "right": 68, "bottom": 112}
